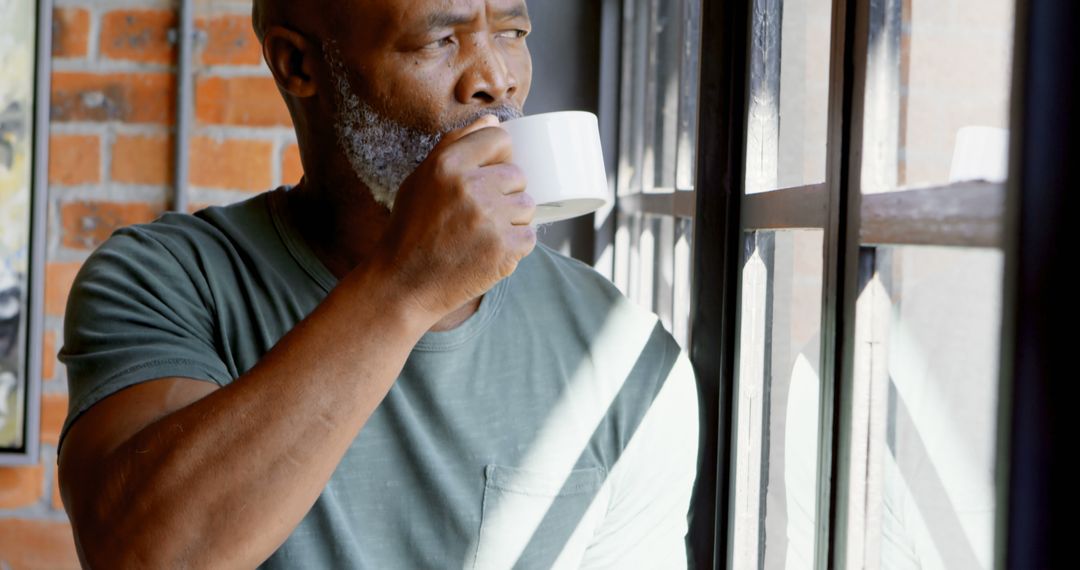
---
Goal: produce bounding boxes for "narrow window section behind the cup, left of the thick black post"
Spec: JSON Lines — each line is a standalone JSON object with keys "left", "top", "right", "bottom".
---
{"left": 615, "top": 0, "right": 701, "bottom": 345}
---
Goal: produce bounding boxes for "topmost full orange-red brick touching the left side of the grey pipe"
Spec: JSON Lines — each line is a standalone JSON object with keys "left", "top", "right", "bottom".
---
{"left": 100, "top": 10, "right": 176, "bottom": 64}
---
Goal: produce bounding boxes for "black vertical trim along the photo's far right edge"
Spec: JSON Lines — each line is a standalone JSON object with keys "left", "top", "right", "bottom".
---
{"left": 996, "top": 0, "right": 1080, "bottom": 569}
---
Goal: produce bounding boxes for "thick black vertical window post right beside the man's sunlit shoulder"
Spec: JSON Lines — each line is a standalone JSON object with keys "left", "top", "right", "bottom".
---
{"left": 689, "top": 0, "right": 751, "bottom": 569}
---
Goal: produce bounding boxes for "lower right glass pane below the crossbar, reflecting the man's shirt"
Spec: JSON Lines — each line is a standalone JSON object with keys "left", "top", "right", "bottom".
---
{"left": 848, "top": 246, "right": 1004, "bottom": 569}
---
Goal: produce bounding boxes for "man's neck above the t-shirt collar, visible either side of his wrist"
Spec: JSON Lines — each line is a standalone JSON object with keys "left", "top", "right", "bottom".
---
{"left": 286, "top": 177, "right": 482, "bottom": 331}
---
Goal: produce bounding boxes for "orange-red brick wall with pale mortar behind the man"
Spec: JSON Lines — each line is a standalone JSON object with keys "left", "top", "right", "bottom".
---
{"left": 0, "top": 0, "right": 300, "bottom": 569}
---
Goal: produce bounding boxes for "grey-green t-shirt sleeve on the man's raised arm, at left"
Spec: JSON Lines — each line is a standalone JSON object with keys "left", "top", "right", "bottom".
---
{"left": 59, "top": 227, "right": 229, "bottom": 449}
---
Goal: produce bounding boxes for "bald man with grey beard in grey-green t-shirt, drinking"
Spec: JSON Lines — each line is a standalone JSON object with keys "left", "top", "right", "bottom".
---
{"left": 59, "top": 0, "right": 698, "bottom": 569}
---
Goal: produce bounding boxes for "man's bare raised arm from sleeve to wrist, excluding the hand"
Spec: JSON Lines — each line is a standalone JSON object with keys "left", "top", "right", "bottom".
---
{"left": 59, "top": 261, "right": 424, "bottom": 568}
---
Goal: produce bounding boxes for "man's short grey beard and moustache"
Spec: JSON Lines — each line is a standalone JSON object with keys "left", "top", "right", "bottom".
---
{"left": 323, "top": 40, "right": 523, "bottom": 209}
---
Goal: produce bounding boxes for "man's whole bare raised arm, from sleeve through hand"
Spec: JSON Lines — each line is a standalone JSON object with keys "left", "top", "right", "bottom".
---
{"left": 59, "top": 118, "right": 536, "bottom": 568}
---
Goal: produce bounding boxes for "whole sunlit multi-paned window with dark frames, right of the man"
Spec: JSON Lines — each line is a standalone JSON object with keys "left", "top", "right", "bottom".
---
{"left": 615, "top": 0, "right": 1058, "bottom": 569}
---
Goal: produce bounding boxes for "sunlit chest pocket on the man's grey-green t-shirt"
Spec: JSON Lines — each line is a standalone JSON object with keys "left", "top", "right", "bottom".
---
{"left": 472, "top": 465, "right": 607, "bottom": 570}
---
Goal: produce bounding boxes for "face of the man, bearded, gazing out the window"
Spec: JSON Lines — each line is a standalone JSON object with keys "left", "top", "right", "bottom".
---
{"left": 323, "top": 0, "right": 532, "bottom": 207}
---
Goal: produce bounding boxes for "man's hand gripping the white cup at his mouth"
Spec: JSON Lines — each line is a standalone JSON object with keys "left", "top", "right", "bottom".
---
{"left": 376, "top": 116, "right": 536, "bottom": 321}
